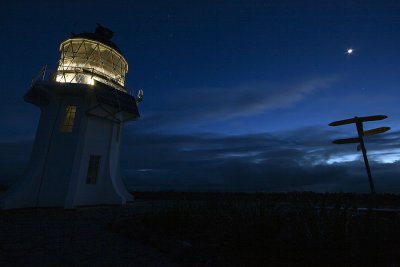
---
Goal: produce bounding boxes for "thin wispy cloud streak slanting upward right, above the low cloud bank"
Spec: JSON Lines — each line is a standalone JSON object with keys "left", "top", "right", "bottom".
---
{"left": 134, "top": 76, "right": 340, "bottom": 129}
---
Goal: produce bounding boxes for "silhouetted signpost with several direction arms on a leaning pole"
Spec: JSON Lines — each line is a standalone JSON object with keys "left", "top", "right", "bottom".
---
{"left": 329, "top": 115, "right": 390, "bottom": 195}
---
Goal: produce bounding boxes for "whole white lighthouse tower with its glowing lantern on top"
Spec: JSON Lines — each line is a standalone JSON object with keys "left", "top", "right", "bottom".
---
{"left": 0, "top": 25, "right": 140, "bottom": 209}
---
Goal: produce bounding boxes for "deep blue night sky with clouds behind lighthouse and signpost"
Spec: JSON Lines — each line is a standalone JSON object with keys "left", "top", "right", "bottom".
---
{"left": 0, "top": 0, "right": 400, "bottom": 193}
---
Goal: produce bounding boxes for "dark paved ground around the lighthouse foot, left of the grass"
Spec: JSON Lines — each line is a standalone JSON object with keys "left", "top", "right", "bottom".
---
{"left": 0, "top": 201, "right": 176, "bottom": 266}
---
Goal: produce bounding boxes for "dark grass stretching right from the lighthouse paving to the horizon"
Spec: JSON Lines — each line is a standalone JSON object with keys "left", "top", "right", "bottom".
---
{"left": 109, "top": 192, "right": 400, "bottom": 266}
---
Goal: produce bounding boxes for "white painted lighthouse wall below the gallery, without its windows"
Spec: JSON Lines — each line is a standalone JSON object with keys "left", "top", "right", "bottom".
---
{"left": 0, "top": 82, "right": 133, "bottom": 208}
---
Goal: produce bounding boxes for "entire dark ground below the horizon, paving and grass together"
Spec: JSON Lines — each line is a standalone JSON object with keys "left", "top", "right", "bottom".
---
{"left": 0, "top": 192, "right": 400, "bottom": 266}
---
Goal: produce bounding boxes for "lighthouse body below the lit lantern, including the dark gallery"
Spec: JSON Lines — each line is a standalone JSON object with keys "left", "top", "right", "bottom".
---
{"left": 0, "top": 82, "right": 139, "bottom": 209}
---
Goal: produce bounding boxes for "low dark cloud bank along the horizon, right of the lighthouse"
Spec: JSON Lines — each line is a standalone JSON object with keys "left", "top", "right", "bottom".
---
{"left": 121, "top": 127, "right": 400, "bottom": 192}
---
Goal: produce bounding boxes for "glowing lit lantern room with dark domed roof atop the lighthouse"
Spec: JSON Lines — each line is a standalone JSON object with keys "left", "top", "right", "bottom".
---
{"left": 54, "top": 25, "right": 128, "bottom": 92}
